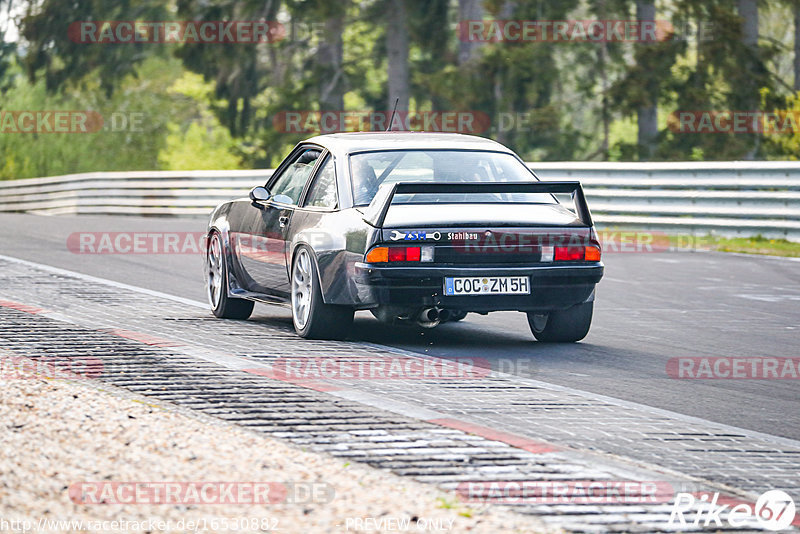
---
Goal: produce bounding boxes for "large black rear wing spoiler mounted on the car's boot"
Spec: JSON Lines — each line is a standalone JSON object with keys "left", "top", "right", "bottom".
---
{"left": 364, "top": 182, "right": 592, "bottom": 228}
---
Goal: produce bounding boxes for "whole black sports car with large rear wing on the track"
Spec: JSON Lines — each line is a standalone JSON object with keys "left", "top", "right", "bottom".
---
{"left": 205, "top": 132, "right": 603, "bottom": 342}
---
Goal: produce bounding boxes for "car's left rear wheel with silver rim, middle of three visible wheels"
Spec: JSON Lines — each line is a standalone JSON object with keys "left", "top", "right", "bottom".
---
{"left": 291, "top": 246, "right": 354, "bottom": 339}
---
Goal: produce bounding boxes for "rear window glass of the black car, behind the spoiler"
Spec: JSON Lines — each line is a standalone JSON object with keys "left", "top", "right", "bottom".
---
{"left": 350, "top": 150, "right": 555, "bottom": 206}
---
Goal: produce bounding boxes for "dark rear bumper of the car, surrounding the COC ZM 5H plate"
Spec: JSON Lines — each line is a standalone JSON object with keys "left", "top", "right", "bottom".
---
{"left": 353, "top": 262, "right": 603, "bottom": 312}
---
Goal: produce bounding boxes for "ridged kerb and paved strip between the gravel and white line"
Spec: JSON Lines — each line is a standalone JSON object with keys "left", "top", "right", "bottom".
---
{"left": 0, "top": 252, "right": 800, "bottom": 532}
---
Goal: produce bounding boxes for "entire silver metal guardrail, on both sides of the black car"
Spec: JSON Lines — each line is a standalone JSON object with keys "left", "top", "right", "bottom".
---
{"left": 0, "top": 162, "right": 800, "bottom": 240}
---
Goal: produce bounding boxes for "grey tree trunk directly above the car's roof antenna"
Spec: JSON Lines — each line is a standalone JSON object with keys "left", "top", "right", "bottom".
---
{"left": 386, "top": 0, "right": 410, "bottom": 119}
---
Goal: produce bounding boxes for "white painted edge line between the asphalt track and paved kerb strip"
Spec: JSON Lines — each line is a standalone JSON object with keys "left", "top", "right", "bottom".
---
{"left": 0, "top": 255, "right": 800, "bottom": 454}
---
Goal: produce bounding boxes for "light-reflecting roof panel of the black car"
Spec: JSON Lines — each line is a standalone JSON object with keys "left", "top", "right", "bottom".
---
{"left": 306, "top": 131, "right": 513, "bottom": 154}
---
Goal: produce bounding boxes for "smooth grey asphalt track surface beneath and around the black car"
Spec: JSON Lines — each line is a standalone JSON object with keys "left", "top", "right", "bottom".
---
{"left": 0, "top": 214, "right": 800, "bottom": 439}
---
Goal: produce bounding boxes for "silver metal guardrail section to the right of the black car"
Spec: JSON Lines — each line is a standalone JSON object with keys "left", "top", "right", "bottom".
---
{"left": 530, "top": 161, "right": 800, "bottom": 240}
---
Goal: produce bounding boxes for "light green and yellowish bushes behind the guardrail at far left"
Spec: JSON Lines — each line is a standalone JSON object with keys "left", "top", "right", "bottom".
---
{"left": 0, "top": 57, "right": 231, "bottom": 179}
